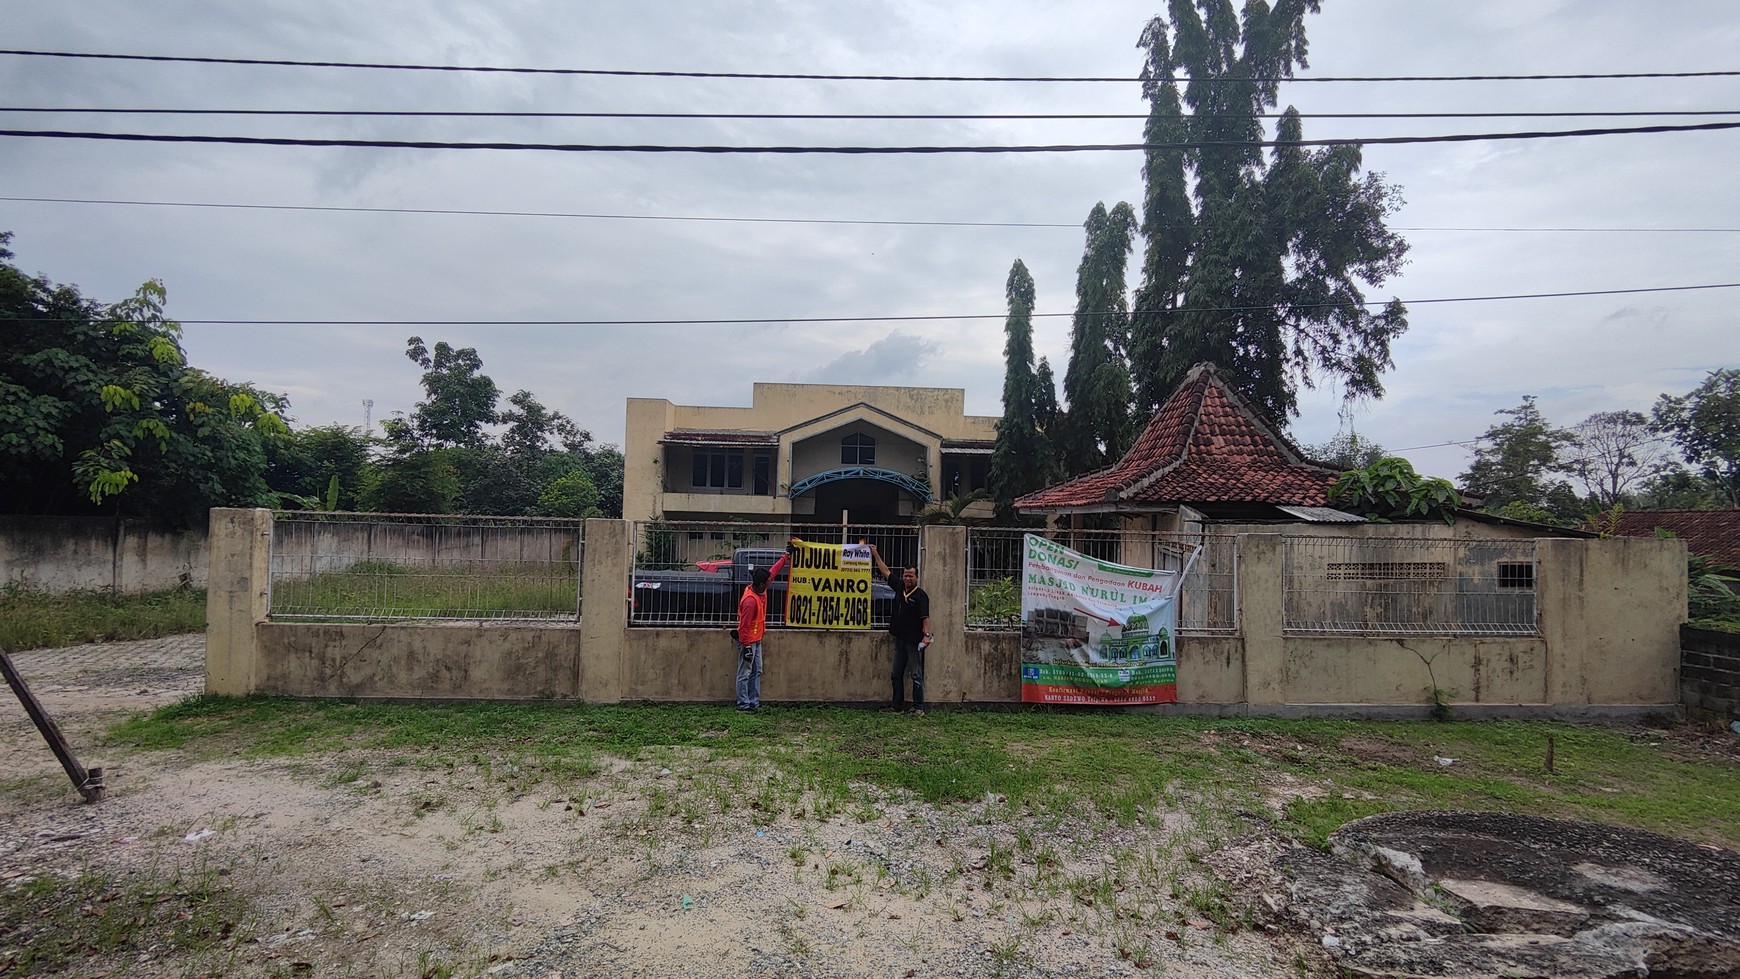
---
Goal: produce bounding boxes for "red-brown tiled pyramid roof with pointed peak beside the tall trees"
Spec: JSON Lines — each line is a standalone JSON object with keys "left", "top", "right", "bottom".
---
{"left": 1014, "top": 363, "right": 1338, "bottom": 511}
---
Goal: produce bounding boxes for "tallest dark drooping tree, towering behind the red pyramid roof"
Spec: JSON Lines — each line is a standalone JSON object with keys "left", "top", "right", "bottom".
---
{"left": 1131, "top": 0, "right": 1408, "bottom": 421}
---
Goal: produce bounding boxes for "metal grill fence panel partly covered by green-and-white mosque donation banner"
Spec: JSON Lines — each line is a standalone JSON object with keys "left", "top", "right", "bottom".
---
{"left": 967, "top": 527, "right": 1239, "bottom": 635}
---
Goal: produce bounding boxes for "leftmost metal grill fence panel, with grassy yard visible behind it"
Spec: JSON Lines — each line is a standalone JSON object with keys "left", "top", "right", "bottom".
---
{"left": 268, "top": 511, "right": 585, "bottom": 621}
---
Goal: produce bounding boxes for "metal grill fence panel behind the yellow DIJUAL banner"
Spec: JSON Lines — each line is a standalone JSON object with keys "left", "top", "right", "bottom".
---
{"left": 628, "top": 520, "right": 922, "bottom": 629}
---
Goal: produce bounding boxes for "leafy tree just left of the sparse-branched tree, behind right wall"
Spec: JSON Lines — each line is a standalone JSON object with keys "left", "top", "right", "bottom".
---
{"left": 1462, "top": 395, "right": 1582, "bottom": 520}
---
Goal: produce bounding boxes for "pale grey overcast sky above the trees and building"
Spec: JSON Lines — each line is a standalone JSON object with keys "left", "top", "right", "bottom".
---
{"left": 0, "top": 0, "right": 1740, "bottom": 476}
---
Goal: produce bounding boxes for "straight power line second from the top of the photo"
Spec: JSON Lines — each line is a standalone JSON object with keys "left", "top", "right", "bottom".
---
{"left": 0, "top": 106, "right": 1740, "bottom": 122}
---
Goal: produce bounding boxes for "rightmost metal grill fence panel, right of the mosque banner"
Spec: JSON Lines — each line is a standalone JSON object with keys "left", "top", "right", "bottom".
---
{"left": 1282, "top": 537, "right": 1540, "bottom": 636}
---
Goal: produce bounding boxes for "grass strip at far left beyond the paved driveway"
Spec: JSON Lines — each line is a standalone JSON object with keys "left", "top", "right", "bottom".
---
{"left": 0, "top": 581, "right": 205, "bottom": 652}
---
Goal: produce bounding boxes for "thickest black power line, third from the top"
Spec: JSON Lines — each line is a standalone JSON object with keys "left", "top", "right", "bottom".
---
{"left": 10, "top": 122, "right": 1740, "bottom": 157}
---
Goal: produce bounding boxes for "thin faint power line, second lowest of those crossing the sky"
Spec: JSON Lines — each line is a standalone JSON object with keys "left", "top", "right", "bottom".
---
{"left": 10, "top": 195, "right": 1740, "bottom": 235}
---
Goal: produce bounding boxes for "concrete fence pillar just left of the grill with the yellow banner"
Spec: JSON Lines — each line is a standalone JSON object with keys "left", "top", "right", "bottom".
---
{"left": 574, "top": 518, "right": 635, "bottom": 704}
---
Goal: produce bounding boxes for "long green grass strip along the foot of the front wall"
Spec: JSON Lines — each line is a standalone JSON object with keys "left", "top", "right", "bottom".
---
{"left": 110, "top": 697, "right": 1740, "bottom": 847}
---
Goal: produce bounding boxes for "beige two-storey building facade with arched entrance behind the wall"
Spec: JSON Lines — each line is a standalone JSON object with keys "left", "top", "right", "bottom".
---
{"left": 623, "top": 383, "right": 997, "bottom": 525}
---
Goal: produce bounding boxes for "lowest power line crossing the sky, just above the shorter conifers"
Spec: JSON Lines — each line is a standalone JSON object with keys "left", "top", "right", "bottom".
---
{"left": 0, "top": 282, "right": 1740, "bottom": 327}
